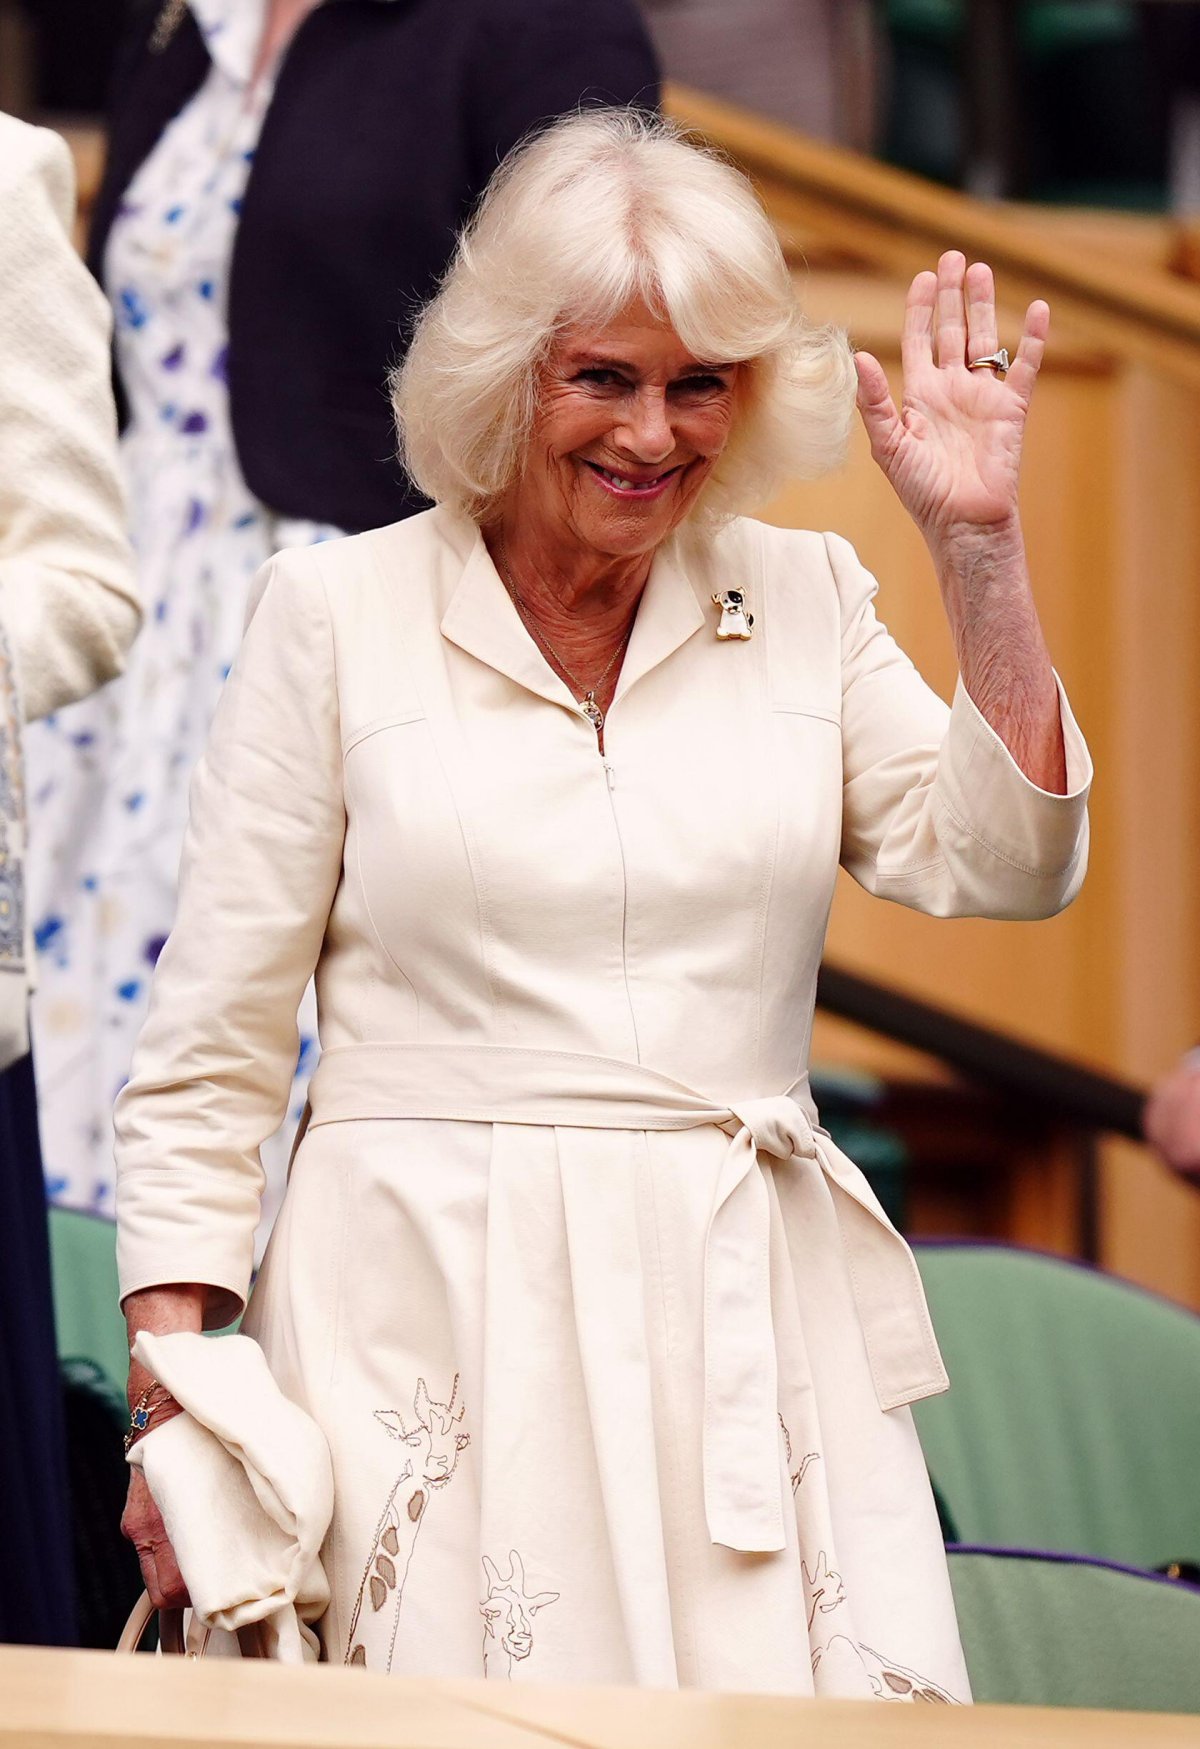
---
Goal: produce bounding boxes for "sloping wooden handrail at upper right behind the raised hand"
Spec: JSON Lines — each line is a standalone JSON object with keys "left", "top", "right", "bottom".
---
{"left": 666, "top": 86, "right": 1200, "bottom": 381}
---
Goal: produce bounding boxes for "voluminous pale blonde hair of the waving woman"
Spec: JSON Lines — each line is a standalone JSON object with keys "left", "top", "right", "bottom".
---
{"left": 398, "top": 110, "right": 854, "bottom": 521}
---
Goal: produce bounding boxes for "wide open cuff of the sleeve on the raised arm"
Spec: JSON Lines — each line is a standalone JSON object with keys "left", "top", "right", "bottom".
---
{"left": 939, "top": 673, "right": 1092, "bottom": 878}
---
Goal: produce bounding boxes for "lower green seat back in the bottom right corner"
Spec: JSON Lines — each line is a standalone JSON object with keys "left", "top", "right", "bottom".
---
{"left": 946, "top": 1548, "right": 1200, "bottom": 1707}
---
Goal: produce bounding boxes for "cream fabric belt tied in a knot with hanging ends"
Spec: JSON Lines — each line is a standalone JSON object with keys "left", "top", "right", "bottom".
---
{"left": 308, "top": 1044, "right": 950, "bottom": 1553}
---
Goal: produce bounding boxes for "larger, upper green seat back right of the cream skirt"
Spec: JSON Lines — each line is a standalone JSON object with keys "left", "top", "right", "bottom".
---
{"left": 915, "top": 1244, "right": 1200, "bottom": 1574}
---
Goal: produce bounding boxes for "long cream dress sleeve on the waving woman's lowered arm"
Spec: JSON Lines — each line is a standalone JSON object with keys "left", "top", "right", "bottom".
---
{"left": 115, "top": 551, "right": 345, "bottom": 1326}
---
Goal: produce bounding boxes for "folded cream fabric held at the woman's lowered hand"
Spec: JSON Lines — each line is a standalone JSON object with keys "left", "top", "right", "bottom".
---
{"left": 129, "top": 1331, "right": 334, "bottom": 1663}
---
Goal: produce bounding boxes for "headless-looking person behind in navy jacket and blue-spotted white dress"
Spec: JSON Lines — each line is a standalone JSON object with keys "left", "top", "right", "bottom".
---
{"left": 28, "top": 0, "right": 658, "bottom": 1212}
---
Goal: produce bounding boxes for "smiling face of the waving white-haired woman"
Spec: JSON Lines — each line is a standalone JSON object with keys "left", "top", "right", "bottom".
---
{"left": 506, "top": 303, "right": 743, "bottom": 558}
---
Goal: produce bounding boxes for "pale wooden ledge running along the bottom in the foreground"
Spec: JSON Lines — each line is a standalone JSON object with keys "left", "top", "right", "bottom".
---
{"left": 0, "top": 1646, "right": 1197, "bottom": 1749}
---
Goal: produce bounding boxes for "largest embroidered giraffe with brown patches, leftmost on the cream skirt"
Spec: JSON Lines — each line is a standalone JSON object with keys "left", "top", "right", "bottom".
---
{"left": 345, "top": 1373, "right": 471, "bottom": 1670}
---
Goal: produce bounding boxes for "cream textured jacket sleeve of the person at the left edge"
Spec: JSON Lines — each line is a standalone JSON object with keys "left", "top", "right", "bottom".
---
{"left": 0, "top": 115, "right": 142, "bottom": 719}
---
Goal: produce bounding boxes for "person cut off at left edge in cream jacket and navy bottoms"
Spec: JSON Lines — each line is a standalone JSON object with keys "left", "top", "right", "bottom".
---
{"left": 0, "top": 114, "right": 140, "bottom": 1646}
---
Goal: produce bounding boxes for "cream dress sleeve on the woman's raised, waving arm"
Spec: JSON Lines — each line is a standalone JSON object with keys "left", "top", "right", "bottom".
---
{"left": 826, "top": 535, "right": 1092, "bottom": 918}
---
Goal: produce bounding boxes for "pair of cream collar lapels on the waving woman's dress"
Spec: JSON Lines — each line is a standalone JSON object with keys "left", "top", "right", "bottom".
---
{"left": 441, "top": 528, "right": 705, "bottom": 712}
